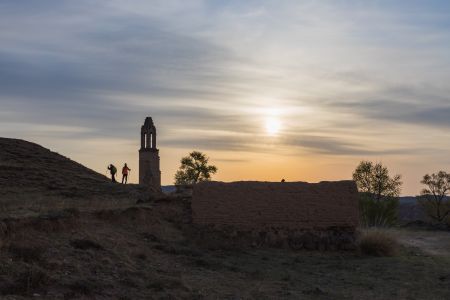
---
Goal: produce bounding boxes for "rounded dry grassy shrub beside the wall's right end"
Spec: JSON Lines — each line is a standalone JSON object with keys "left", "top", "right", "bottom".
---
{"left": 359, "top": 229, "right": 399, "bottom": 256}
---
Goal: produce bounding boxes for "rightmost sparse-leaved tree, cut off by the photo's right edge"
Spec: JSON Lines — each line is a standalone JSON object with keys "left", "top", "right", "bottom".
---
{"left": 419, "top": 171, "right": 450, "bottom": 223}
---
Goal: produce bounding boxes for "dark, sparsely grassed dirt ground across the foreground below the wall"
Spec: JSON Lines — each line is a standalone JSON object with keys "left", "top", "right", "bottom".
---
{"left": 0, "top": 201, "right": 450, "bottom": 299}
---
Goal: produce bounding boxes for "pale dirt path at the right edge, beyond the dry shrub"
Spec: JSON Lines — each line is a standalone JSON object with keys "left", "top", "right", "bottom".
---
{"left": 394, "top": 230, "right": 450, "bottom": 256}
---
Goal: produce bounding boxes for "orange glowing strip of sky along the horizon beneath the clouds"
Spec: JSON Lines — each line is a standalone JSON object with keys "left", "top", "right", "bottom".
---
{"left": 13, "top": 130, "right": 439, "bottom": 196}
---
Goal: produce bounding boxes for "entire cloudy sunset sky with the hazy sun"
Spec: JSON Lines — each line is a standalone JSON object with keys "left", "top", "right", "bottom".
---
{"left": 0, "top": 0, "right": 450, "bottom": 195}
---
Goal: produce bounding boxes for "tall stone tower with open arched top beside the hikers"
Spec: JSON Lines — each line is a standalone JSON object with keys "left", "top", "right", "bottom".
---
{"left": 139, "top": 117, "right": 161, "bottom": 191}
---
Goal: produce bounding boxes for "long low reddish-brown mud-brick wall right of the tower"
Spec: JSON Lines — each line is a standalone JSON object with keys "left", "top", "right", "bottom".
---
{"left": 192, "top": 181, "right": 359, "bottom": 230}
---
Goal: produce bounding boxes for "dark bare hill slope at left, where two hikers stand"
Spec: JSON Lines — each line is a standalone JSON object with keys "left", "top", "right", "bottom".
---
{"left": 0, "top": 138, "right": 151, "bottom": 217}
